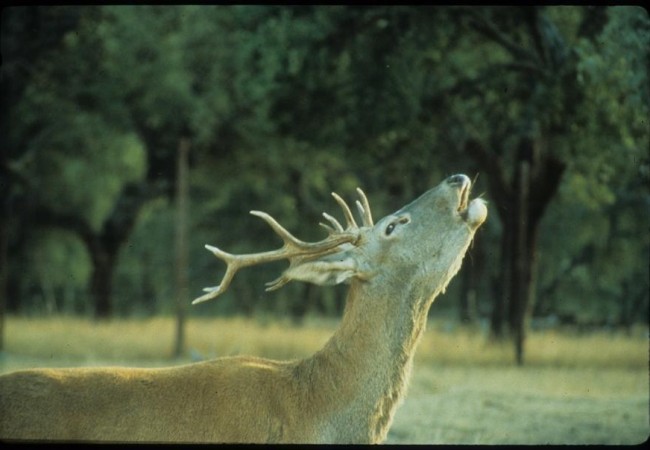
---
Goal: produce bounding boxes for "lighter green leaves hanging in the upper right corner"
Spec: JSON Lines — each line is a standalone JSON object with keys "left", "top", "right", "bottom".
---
{"left": 567, "top": 7, "right": 650, "bottom": 188}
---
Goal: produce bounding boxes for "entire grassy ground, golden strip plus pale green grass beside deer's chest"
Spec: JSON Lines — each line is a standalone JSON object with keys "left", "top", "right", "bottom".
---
{"left": 0, "top": 317, "right": 650, "bottom": 444}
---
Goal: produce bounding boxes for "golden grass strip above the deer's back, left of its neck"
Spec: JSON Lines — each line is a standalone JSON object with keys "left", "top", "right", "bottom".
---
{"left": 0, "top": 317, "right": 335, "bottom": 364}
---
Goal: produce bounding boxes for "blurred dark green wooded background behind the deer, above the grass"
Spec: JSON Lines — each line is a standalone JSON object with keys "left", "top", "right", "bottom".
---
{"left": 0, "top": 6, "right": 650, "bottom": 442}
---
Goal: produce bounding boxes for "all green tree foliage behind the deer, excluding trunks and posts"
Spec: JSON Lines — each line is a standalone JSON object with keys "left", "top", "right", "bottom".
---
{"left": 3, "top": 5, "right": 650, "bottom": 326}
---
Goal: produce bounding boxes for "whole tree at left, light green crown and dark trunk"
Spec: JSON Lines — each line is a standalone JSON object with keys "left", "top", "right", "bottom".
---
{"left": 5, "top": 8, "right": 151, "bottom": 317}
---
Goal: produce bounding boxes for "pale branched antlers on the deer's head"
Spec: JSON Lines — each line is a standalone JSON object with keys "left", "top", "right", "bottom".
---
{"left": 192, "top": 188, "right": 373, "bottom": 305}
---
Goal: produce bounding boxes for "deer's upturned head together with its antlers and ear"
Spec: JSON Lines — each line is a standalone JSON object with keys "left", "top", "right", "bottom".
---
{"left": 192, "top": 175, "right": 487, "bottom": 304}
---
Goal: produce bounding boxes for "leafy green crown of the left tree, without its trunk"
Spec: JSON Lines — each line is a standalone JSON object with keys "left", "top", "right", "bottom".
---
{"left": 11, "top": 5, "right": 146, "bottom": 230}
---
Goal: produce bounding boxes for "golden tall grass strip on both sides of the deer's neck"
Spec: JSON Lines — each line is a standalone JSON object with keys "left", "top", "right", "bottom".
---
{"left": 5, "top": 316, "right": 648, "bottom": 369}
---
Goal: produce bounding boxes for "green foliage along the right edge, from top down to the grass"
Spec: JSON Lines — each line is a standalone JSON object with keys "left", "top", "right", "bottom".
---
{"left": 540, "top": 7, "right": 650, "bottom": 322}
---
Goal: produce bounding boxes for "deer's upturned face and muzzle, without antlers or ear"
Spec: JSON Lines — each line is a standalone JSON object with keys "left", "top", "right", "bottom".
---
{"left": 349, "top": 175, "right": 487, "bottom": 300}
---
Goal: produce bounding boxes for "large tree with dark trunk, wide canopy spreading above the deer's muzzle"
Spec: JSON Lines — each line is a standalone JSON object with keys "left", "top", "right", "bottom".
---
{"left": 221, "top": 7, "right": 648, "bottom": 362}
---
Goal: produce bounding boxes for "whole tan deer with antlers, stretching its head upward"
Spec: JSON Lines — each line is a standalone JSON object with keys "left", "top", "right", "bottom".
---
{"left": 0, "top": 174, "right": 487, "bottom": 444}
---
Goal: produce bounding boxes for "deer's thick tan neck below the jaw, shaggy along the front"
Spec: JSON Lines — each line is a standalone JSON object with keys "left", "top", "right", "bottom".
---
{"left": 302, "top": 272, "right": 437, "bottom": 442}
